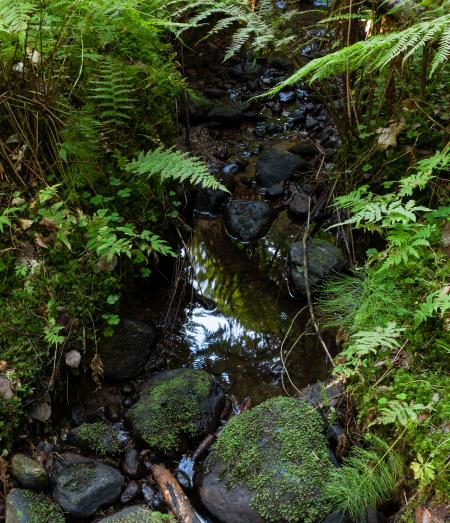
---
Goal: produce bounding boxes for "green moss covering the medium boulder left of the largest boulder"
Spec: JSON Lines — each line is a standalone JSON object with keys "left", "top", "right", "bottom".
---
{"left": 130, "top": 369, "right": 213, "bottom": 453}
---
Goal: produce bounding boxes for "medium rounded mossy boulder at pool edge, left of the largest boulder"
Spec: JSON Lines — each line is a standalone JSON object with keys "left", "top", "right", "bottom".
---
{"left": 129, "top": 369, "right": 225, "bottom": 454}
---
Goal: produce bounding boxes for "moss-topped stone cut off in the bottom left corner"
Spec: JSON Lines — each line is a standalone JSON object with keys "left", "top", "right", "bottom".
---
{"left": 6, "top": 488, "right": 65, "bottom": 523}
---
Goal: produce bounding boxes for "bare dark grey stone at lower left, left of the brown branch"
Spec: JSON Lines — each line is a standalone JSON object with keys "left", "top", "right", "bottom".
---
{"left": 51, "top": 454, "right": 124, "bottom": 518}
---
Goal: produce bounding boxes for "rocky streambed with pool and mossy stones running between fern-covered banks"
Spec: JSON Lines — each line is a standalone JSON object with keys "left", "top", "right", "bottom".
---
{"left": 2, "top": 2, "right": 362, "bottom": 523}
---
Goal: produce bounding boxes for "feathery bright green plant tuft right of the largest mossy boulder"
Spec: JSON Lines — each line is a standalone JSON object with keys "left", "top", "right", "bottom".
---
{"left": 325, "top": 434, "right": 403, "bottom": 521}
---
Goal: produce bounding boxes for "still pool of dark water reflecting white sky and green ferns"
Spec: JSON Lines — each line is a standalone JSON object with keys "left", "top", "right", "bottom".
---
{"left": 165, "top": 216, "right": 326, "bottom": 402}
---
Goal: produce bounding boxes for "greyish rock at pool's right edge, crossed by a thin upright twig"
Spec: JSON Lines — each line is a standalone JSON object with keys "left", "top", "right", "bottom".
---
{"left": 289, "top": 239, "right": 346, "bottom": 294}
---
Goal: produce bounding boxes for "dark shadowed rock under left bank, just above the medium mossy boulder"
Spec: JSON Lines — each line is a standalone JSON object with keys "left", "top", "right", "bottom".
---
{"left": 99, "top": 320, "right": 156, "bottom": 381}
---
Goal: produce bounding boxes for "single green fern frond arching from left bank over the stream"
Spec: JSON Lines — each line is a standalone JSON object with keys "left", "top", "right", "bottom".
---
{"left": 125, "top": 147, "right": 228, "bottom": 191}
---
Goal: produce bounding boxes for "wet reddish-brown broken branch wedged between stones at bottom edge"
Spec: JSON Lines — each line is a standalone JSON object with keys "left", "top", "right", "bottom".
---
{"left": 151, "top": 464, "right": 201, "bottom": 523}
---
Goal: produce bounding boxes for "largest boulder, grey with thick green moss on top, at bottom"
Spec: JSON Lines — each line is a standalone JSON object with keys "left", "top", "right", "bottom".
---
{"left": 200, "top": 397, "right": 334, "bottom": 523}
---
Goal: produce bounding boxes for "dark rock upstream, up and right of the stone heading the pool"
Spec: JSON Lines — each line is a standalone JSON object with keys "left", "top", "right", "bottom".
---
{"left": 256, "top": 149, "right": 307, "bottom": 187}
